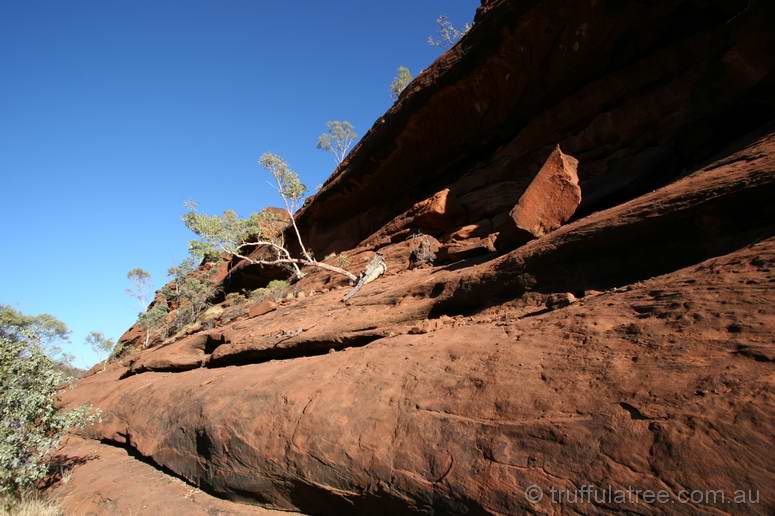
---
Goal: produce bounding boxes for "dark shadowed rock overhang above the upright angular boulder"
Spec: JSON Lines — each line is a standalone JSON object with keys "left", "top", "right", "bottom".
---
{"left": 292, "top": 0, "right": 775, "bottom": 255}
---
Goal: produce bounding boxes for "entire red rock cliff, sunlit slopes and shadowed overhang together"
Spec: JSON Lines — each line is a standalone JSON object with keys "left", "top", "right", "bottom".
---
{"left": 51, "top": 0, "right": 775, "bottom": 515}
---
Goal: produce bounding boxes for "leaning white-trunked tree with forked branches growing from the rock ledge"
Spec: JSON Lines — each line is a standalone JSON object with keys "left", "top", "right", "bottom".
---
{"left": 183, "top": 152, "right": 357, "bottom": 281}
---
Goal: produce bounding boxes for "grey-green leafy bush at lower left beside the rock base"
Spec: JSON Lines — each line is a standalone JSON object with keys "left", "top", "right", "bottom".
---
{"left": 0, "top": 330, "right": 98, "bottom": 496}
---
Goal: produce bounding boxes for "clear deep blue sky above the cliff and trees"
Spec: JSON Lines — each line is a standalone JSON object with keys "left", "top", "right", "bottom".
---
{"left": 0, "top": 0, "right": 479, "bottom": 367}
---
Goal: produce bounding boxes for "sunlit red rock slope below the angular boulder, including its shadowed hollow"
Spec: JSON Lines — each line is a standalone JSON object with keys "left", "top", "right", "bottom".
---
{"left": 54, "top": 128, "right": 775, "bottom": 514}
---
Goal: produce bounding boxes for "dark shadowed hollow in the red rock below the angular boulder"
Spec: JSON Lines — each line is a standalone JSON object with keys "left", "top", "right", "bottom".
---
{"left": 430, "top": 128, "right": 775, "bottom": 317}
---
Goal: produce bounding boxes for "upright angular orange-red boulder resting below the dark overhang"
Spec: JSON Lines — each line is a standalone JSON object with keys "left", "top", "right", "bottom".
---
{"left": 509, "top": 145, "right": 581, "bottom": 238}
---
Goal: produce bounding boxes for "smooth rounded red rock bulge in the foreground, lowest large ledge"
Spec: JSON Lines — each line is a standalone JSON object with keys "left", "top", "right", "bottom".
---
{"left": 59, "top": 239, "right": 775, "bottom": 514}
